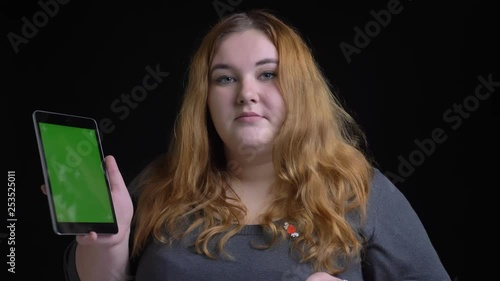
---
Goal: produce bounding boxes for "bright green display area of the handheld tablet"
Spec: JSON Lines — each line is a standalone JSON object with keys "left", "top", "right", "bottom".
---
{"left": 40, "top": 123, "right": 113, "bottom": 222}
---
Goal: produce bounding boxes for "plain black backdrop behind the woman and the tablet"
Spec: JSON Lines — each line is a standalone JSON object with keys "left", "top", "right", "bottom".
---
{"left": 0, "top": 0, "right": 500, "bottom": 280}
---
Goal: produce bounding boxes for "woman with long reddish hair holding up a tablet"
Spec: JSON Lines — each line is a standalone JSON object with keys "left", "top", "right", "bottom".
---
{"left": 56, "top": 8, "right": 450, "bottom": 281}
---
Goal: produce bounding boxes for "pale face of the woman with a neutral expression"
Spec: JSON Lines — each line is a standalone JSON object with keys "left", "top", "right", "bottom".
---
{"left": 208, "top": 29, "right": 285, "bottom": 155}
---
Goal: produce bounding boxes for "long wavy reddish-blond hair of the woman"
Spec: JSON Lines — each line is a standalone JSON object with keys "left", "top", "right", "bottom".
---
{"left": 132, "top": 10, "right": 373, "bottom": 274}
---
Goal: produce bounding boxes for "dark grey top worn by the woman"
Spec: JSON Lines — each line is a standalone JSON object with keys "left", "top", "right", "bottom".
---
{"left": 64, "top": 167, "right": 451, "bottom": 281}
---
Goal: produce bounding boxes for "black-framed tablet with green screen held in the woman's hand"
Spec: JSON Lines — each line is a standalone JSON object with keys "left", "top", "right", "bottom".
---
{"left": 32, "top": 110, "right": 118, "bottom": 235}
